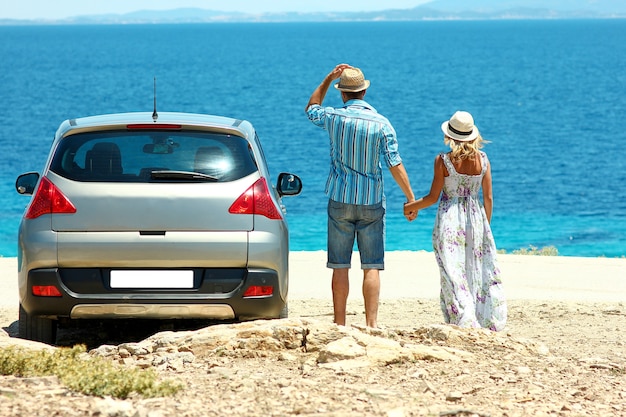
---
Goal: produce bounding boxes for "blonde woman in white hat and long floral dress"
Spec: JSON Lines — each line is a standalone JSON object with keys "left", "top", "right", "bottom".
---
{"left": 404, "top": 111, "right": 507, "bottom": 331}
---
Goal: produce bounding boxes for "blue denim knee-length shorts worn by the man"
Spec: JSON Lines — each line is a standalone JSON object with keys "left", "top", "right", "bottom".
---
{"left": 326, "top": 200, "right": 385, "bottom": 269}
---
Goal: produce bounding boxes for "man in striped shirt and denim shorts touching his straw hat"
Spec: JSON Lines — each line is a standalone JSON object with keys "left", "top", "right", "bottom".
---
{"left": 305, "top": 64, "right": 415, "bottom": 327}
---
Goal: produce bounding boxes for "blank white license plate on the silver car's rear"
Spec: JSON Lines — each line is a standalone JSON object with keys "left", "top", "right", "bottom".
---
{"left": 111, "top": 271, "right": 193, "bottom": 288}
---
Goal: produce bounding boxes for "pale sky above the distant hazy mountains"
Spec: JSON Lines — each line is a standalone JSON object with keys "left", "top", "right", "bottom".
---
{"left": 0, "top": 0, "right": 428, "bottom": 19}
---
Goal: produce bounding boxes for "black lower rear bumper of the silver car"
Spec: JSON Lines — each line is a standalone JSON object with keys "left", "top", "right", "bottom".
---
{"left": 20, "top": 268, "right": 286, "bottom": 320}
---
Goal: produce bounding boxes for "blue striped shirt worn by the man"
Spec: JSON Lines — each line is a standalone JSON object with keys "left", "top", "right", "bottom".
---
{"left": 307, "top": 100, "right": 402, "bottom": 205}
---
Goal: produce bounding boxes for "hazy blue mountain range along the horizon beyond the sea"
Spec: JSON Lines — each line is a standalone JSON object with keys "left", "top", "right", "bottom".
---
{"left": 0, "top": 0, "right": 626, "bottom": 25}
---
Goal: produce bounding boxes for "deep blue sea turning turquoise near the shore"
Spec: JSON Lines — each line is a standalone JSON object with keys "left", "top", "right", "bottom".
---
{"left": 0, "top": 19, "right": 626, "bottom": 257}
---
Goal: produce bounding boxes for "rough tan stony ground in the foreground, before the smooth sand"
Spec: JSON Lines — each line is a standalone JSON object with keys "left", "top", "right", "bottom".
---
{"left": 0, "top": 299, "right": 626, "bottom": 417}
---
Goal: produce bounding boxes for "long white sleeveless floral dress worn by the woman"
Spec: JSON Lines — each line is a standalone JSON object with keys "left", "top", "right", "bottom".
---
{"left": 433, "top": 152, "right": 507, "bottom": 331}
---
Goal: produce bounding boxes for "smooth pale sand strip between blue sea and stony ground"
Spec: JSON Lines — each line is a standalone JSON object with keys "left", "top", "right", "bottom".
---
{"left": 0, "top": 251, "right": 626, "bottom": 307}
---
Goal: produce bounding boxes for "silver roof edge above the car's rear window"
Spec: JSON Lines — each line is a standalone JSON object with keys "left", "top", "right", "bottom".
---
{"left": 56, "top": 112, "right": 254, "bottom": 139}
